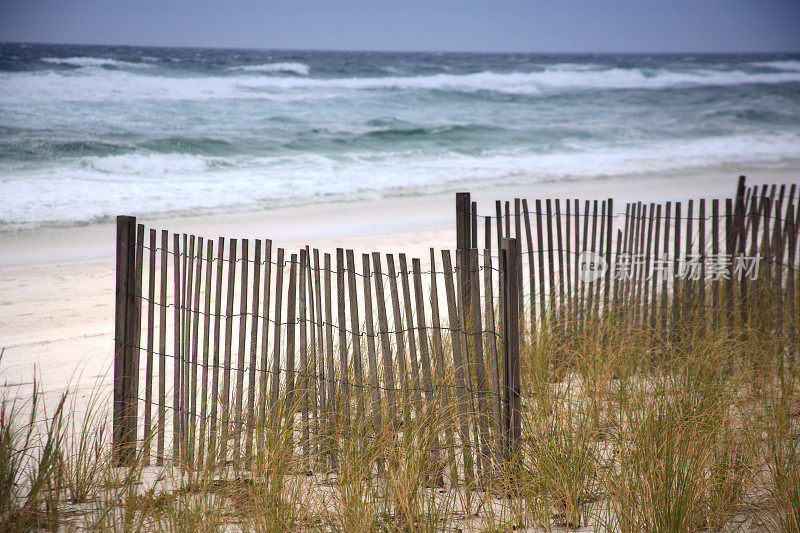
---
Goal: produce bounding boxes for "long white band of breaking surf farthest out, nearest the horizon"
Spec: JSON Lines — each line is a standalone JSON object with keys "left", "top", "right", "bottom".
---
{"left": 6, "top": 65, "right": 800, "bottom": 103}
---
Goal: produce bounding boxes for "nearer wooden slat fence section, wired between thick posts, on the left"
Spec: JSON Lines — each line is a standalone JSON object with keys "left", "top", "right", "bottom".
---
{"left": 114, "top": 216, "right": 520, "bottom": 483}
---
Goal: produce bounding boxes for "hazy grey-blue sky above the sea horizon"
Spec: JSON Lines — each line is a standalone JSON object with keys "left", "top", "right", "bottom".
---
{"left": 0, "top": 0, "right": 800, "bottom": 52}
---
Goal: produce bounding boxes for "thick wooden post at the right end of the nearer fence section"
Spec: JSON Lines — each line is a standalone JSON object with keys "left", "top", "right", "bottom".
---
{"left": 500, "top": 238, "right": 522, "bottom": 461}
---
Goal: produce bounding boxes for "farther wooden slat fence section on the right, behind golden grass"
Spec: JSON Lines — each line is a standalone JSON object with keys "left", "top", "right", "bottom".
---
{"left": 461, "top": 177, "right": 800, "bottom": 342}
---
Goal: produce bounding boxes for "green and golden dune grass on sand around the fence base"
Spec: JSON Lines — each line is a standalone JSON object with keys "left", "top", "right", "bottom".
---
{"left": 0, "top": 286, "right": 800, "bottom": 532}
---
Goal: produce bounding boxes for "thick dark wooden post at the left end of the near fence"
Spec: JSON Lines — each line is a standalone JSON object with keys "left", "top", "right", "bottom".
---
{"left": 112, "top": 215, "right": 138, "bottom": 466}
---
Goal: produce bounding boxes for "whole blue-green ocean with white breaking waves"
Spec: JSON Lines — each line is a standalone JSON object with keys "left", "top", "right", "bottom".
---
{"left": 0, "top": 43, "right": 800, "bottom": 231}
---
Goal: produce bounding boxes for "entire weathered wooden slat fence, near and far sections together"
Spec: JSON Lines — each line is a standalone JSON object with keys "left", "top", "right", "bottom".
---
{"left": 114, "top": 178, "right": 800, "bottom": 486}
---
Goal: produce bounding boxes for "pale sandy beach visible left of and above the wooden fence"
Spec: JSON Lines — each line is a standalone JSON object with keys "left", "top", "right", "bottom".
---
{"left": 0, "top": 169, "right": 800, "bottom": 398}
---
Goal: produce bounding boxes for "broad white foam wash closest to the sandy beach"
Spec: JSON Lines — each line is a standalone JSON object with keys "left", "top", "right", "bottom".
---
{"left": 0, "top": 135, "right": 800, "bottom": 230}
